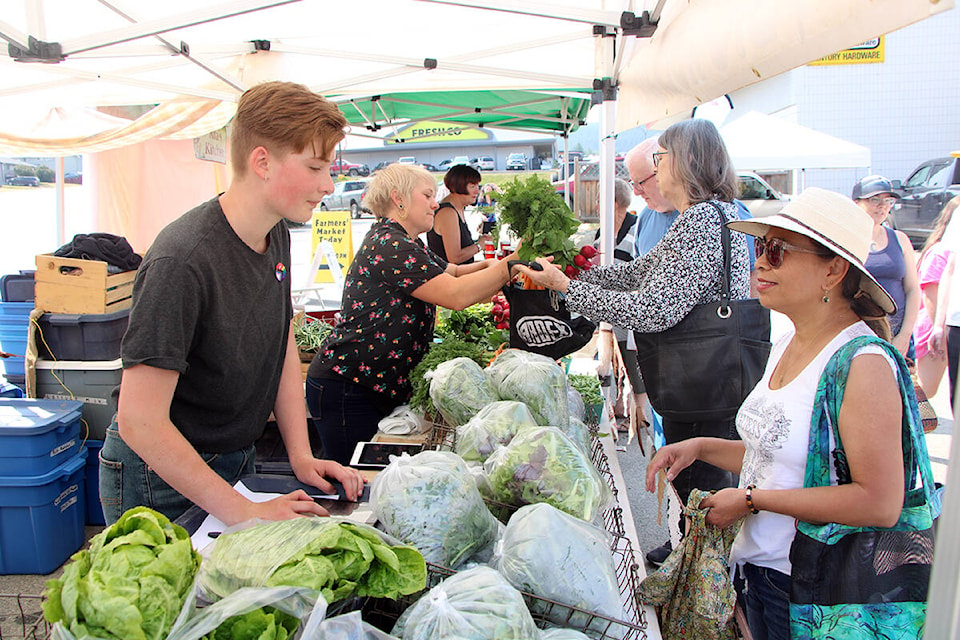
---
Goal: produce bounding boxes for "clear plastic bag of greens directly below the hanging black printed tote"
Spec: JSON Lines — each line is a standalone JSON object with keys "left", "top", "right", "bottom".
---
{"left": 487, "top": 349, "right": 570, "bottom": 427}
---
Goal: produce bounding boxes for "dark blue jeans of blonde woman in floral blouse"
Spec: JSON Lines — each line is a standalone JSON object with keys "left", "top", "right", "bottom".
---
{"left": 307, "top": 377, "right": 386, "bottom": 464}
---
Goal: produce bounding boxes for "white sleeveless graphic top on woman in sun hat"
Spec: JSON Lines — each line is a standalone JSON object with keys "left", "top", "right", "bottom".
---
{"left": 730, "top": 322, "right": 896, "bottom": 575}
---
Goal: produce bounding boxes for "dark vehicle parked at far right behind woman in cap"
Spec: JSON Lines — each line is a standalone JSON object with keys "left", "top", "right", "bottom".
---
{"left": 887, "top": 154, "right": 960, "bottom": 248}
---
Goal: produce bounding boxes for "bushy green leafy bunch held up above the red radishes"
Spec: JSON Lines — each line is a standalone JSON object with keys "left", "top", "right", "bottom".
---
{"left": 499, "top": 174, "right": 580, "bottom": 267}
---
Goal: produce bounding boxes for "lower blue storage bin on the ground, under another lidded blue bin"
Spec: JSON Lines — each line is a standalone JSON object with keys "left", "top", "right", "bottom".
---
{"left": 0, "top": 450, "right": 86, "bottom": 575}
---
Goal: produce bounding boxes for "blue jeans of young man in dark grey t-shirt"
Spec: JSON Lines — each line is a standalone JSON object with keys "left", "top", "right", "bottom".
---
{"left": 100, "top": 419, "right": 257, "bottom": 525}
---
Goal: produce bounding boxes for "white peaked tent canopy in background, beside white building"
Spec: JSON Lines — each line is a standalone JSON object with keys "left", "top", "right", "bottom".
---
{"left": 720, "top": 111, "right": 870, "bottom": 171}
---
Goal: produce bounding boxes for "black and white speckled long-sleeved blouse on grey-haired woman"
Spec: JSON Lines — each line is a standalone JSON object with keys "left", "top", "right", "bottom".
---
{"left": 566, "top": 200, "right": 750, "bottom": 333}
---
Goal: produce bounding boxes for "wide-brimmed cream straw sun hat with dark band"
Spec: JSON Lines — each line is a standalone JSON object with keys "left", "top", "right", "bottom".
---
{"left": 727, "top": 187, "right": 897, "bottom": 314}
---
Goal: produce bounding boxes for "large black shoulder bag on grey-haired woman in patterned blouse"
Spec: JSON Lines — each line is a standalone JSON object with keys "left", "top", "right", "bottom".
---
{"left": 634, "top": 203, "right": 770, "bottom": 422}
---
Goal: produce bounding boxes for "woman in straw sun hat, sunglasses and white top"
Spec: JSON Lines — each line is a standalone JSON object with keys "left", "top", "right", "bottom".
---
{"left": 646, "top": 188, "right": 929, "bottom": 638}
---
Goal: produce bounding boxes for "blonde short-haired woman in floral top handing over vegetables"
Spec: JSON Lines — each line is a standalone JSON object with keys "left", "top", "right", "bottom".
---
{"left": 307, "top": 164, "right": 508, "bottom": 463}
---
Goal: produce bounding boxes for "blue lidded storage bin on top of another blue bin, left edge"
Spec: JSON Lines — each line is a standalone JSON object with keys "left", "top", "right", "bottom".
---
{"left": 0, "top": 398, "right": 82, "bottom": 476}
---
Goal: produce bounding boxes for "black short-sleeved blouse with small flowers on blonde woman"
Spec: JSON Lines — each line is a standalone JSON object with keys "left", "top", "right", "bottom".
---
{"left": 308, "top": 219, "right": 446, "bottom": 404}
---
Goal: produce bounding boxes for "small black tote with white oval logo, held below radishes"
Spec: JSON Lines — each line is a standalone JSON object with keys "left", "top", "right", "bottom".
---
{"left": 503, "top": 261, "right": 597, "bottom": 360}
